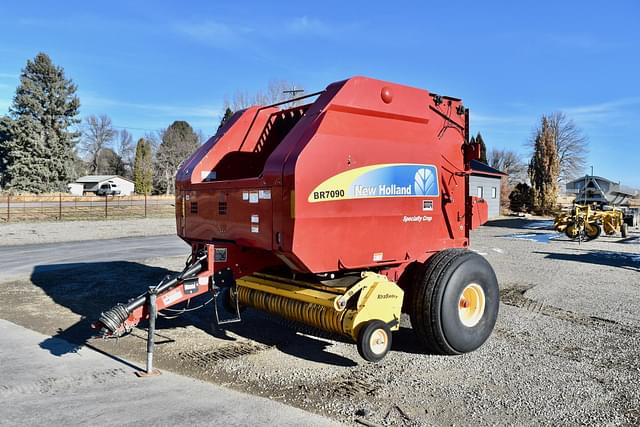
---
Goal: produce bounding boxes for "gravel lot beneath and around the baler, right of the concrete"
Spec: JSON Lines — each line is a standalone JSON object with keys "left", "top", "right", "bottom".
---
{"left": 0, "top": 219, "right": 640, "bottom": 426}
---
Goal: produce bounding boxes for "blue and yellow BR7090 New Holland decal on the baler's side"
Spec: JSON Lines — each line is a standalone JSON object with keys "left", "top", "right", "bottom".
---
{"left": 308, "top": 163, "right": 440, "bottom": 203}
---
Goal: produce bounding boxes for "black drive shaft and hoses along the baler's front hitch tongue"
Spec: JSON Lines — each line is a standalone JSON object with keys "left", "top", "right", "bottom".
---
{"left": 98, "top": 255, "right": 207, "bottom": 334}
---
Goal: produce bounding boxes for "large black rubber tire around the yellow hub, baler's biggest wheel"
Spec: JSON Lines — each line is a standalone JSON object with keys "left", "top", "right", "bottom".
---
{"left": 409, "top": 249, "right": 500, "bottom": 355}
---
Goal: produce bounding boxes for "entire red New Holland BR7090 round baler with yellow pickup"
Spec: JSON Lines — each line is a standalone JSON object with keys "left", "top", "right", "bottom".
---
{"left": 96, "top": 77, "right": 499, "bottom": 361}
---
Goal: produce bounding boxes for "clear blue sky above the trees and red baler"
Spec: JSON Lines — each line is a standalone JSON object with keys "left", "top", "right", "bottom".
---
{"left": 0, "top": 0, "right": 640, "bottom": 187}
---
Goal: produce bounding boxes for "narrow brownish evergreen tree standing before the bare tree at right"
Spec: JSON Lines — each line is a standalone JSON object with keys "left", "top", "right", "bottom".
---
{"left": 529, "top": 116, "right": 560, "bottom": 214}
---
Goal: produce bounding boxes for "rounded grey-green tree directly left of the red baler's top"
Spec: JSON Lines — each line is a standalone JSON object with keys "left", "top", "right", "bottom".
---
{"left": 154, "top": 120, "right": 200, "bottom": 194}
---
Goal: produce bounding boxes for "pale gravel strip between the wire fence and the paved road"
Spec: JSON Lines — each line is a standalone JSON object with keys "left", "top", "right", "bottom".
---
{"left": 0, "top": 218, "right": 176, "bottom": 246}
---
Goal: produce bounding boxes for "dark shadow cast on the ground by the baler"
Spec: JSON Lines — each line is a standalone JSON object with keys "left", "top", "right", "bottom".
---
{"left": 31, "top": 261, "right": 356, "bottom": 366}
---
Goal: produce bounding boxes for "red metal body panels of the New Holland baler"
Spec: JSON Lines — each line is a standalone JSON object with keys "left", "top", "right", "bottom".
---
{"left": 177, "top": 77, "right": 471, "bottom": 272}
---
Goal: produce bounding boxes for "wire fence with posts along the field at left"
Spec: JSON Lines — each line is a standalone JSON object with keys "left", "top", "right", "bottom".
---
{"left": 0, "top": 194, "right": 175, "bottom": 223}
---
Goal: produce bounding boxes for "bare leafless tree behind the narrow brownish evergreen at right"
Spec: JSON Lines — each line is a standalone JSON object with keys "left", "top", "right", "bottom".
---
{"left": 528, "top": 112, "right": 589, "bottom": 182}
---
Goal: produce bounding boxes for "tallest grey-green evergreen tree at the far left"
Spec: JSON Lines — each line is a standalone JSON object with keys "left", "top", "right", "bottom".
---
{"left": 0, "top": 53, "right": 80, "bottom": 193}
